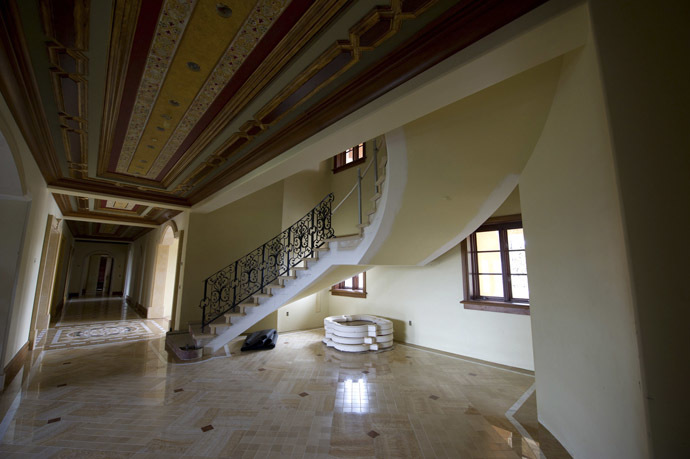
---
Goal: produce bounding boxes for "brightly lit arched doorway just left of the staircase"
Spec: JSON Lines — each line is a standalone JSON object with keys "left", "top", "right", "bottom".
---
{"left": 148, "top": 221, "right": 181, "bottom": 326}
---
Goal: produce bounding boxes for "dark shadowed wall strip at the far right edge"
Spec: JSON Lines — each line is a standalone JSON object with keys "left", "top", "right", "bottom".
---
{"left": 590, "top": 0, "right": 690, "bottom": 458}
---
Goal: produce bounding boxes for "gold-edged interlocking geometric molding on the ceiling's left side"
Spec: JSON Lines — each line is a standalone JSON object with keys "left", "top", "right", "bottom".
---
{"left": 40, "top": 0, "right": 90, "bottom": 178}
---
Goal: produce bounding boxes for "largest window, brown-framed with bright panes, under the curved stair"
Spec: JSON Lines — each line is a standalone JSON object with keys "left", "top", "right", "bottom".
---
{"left": 463, "top": 215, "right": 529, "bottom": 314}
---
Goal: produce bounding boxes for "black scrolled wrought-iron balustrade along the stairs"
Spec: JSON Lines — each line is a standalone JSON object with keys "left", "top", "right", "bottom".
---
{"left": 199, "top": 193, "right": 334, "bottom": 330}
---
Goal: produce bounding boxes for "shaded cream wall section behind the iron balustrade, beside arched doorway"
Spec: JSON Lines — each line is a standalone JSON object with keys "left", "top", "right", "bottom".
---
{"left": 180, "top": 183, "right": 283, "bottom": 328}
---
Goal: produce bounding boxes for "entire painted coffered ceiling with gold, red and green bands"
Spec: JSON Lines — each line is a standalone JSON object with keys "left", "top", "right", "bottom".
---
{"left": 0, "top": 0, "right": 543, "bottom": 239}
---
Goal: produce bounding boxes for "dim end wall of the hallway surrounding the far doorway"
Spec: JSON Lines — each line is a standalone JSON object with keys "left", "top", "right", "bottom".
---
{"left": 69, "top": 241, "right": 129, "bottom": 294}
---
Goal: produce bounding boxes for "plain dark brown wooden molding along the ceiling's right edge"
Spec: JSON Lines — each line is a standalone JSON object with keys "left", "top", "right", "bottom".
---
{"left": 183, "top": 0, "right": 546, "bottom": 204}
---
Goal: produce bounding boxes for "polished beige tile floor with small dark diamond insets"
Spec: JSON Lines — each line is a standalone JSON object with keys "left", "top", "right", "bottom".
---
{"left": 0, "top": 298, "right": 569, "bottom": 458}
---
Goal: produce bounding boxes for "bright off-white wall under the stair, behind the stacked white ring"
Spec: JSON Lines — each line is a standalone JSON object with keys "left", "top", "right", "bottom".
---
{"left": 324, "top": 247, "right": 534, "bottom": 370}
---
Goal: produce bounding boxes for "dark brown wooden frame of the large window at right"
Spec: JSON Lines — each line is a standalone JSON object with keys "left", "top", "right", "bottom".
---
{"left": 460, "top": 214, "right": 530, "bottom": 315}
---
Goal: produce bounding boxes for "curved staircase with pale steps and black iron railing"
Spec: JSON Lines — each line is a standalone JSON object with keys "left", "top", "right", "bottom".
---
{"left": 189, "top": 148, "right": 387, "bottom": 355}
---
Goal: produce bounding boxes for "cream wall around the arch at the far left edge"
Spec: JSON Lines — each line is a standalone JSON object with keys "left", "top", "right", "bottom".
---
{"left": 0, "top": 92, "right": 64, "bottom": 362}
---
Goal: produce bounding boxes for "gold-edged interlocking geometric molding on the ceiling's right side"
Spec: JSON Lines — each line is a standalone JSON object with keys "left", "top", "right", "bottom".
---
{"left": 174, "top": 0, "right": 437, "bottom": 195}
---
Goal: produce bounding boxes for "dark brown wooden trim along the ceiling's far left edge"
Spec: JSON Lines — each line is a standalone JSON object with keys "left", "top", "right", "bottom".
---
{"left": 0, "top": 0, "right": 62, "bottom": 181}
